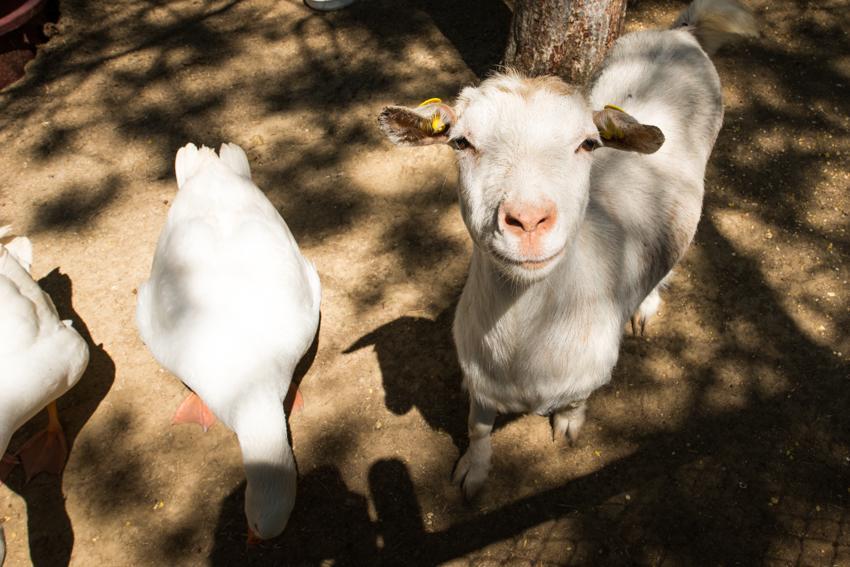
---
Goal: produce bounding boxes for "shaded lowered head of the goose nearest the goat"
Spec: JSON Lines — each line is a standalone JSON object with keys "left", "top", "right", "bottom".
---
{"left": 245, "top": 463, "right": 296, "bottom": 542}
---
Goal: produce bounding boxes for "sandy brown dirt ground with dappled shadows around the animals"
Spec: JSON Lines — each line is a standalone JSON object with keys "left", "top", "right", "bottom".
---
{"left": 0, "top": 0, "right": 850, "bottom": 567}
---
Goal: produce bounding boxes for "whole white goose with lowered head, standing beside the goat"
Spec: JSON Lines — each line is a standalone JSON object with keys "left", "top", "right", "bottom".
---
{"left": 136, "top": 144, "right": 321, "bottom": 539}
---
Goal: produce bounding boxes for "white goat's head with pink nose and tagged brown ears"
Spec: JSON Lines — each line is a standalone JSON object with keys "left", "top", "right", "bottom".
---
{"left": 379, "top": 72, "right": 664, "bottom": 281}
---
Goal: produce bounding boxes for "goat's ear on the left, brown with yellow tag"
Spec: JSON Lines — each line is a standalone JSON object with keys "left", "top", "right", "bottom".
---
{"left": 378, "top": 99, "right": 456, "bottom": 146}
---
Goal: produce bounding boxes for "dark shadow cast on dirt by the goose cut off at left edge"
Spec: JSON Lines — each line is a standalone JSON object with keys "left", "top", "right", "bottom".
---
{"left": 2, "top": 268, "right": 115, "bottom": 567}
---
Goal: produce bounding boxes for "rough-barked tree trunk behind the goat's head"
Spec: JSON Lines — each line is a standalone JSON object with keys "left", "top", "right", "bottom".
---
{"left": 505, "top": 0, "right": 626, "bottom": 84}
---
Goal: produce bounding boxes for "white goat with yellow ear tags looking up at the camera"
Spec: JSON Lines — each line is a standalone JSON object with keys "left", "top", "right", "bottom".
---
{"left": 379, "top": 0, "right": 755, "bottom": 497}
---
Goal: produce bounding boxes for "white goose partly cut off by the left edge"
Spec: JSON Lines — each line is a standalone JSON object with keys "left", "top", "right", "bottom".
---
{"left": 0, "top": 226, "right": 89, "bottom": 480}
